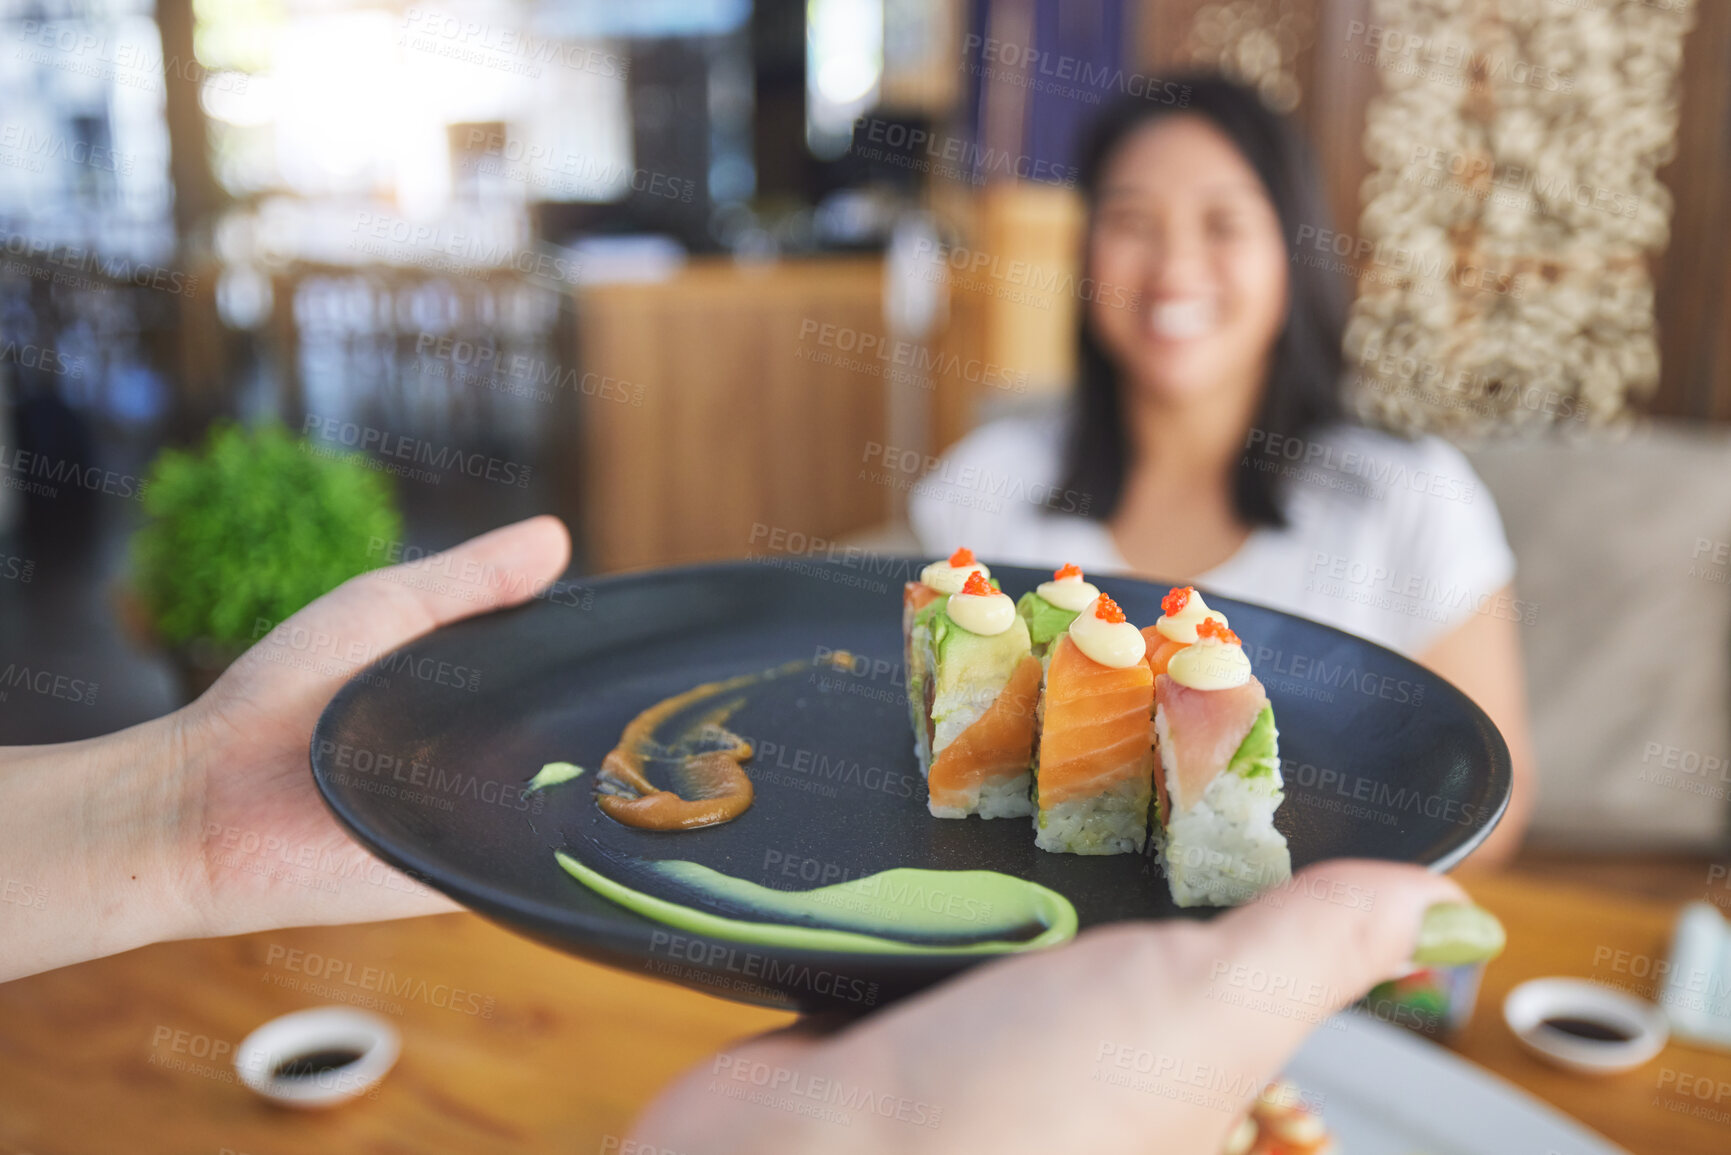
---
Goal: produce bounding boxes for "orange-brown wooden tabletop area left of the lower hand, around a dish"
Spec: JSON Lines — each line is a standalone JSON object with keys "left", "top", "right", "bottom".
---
{"left": 0, "top": 914, "right": 791, "bottom": 1155}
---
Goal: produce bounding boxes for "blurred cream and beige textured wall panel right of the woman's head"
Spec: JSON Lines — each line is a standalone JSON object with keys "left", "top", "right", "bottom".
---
{"left": 1347, "top": 0, "right": 1695, "bottom": 436}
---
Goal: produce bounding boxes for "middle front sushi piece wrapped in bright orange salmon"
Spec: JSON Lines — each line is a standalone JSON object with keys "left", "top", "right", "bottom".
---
{"left": 1033, "top": 594, "right": 1155, "bottom": 854}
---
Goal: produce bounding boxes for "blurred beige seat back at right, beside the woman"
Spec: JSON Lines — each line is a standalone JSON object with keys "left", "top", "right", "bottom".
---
{"left": 1470, "top": 421, "right": 1731, "bottom": 852}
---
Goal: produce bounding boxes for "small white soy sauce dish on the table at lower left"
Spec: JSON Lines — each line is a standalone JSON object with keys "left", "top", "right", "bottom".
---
{"left": 234, "top": 1006, "right": 402, "bottom": 1107}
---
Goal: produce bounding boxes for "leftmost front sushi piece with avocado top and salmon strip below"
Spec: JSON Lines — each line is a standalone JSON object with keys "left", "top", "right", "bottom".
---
{"left": 917, "top": 571, "right": 1040, "bottom": 817}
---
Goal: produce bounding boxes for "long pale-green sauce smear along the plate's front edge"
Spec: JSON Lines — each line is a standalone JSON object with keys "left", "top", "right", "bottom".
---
{"left": 554, "top": 850, "right": 1077, "bottom": 954}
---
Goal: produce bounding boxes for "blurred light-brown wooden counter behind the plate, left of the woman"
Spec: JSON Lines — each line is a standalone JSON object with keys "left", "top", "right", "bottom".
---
{"left": 573, "top": 258, "right": 912, "bottom": 571}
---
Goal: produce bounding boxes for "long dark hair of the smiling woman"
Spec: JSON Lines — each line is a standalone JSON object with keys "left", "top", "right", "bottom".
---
{"left": 1065, "top": 74, "right": 1347, "bottom": 526}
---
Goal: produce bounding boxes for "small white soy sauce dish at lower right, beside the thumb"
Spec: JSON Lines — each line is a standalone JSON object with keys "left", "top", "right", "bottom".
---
{"left": 1503, "top": 978, "right": 1670, "bottom": 1075}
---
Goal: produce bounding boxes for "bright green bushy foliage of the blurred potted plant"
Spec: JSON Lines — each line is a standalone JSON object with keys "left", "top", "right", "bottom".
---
{"left": 128, "top": 424, "right": 402, "bottom": 700}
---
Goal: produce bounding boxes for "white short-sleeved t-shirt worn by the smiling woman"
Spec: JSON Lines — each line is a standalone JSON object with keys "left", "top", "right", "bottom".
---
{"left": 909, "top": 416, "right": 1515, "bottom": 656}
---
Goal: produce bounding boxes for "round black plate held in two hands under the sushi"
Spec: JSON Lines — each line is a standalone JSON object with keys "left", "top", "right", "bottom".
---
{"left": 312, "top": 558, "right": 1511, "bottom": 1010}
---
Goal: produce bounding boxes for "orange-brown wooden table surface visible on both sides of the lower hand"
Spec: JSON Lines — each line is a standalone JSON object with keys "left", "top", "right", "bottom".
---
{"left": 0, "top": 874, "right": 1731, "bottom": 1155}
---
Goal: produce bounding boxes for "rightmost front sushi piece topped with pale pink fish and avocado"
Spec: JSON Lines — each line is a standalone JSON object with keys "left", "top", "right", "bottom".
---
{"left": 1155, "top": 618, "right": 1291, "bottom": 906}
